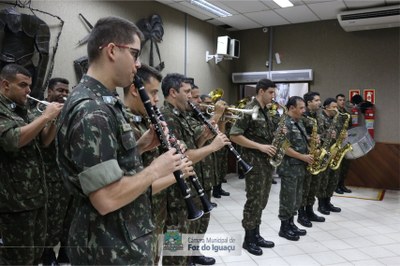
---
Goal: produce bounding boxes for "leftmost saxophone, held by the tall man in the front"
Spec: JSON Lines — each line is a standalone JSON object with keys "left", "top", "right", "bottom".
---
{"left": 269, "top": 102, "right": 290, "bottom": 167}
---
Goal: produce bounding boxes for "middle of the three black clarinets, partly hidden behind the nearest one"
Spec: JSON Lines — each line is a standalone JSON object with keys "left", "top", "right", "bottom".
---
{"left": 153, "top": 106, "right": 214, "bottom": 213}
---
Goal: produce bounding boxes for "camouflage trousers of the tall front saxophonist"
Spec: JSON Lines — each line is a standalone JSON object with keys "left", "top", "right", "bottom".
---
{"left": 242, "top": 163, "right": 273, "bottom": 230}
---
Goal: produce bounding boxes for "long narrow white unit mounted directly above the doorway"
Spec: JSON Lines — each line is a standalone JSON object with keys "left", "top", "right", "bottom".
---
{"left": 232, "top": 69, "right": 313, "bottom": 83}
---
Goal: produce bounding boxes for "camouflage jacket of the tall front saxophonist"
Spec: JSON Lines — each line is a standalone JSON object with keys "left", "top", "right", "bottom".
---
{"left": 229, "top": 99, "right": 278, "bottom": 164}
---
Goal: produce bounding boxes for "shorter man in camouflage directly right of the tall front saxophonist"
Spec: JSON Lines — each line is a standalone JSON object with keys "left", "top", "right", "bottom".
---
{"left": 277, "top": 96, "right": 313, "bottom": 241}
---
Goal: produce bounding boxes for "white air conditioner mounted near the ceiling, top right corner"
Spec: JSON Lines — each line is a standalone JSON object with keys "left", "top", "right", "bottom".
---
{"left": 337, "top": 5, "right": 400, "bottom": 31}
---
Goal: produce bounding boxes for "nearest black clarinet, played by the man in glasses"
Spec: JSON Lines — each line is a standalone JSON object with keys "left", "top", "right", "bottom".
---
{"left": 133, "top": 75, "right": 204, "bottom": 220}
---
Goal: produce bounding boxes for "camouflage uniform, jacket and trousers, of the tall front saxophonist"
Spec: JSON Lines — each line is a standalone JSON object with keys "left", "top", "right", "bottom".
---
{"left": 229, "top": 100, "right": 277, "bottom": 230}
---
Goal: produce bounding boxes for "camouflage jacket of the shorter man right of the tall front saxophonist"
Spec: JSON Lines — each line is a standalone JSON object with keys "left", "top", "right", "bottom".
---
{"left": 277, "top": 116, "right": 308, "bottom": 176}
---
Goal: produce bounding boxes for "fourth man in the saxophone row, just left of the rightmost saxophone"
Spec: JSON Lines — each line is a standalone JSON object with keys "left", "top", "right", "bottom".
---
{"left": 317, "top": 98, "right": 341, "bottom": 215}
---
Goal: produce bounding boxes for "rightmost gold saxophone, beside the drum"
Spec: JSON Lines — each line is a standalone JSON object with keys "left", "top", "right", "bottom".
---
{"left": 329, "top": 113, "right": 353, "bottom": 170}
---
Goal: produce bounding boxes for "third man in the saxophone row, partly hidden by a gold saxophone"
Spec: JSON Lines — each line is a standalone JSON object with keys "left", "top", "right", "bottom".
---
{"left": 297, "top": 91, "right": 325, "bottom": 227}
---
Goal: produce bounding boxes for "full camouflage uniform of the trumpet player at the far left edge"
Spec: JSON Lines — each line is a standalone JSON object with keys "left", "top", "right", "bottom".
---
{"left": 0, "top": 94, "right": 47, "bottom": 265}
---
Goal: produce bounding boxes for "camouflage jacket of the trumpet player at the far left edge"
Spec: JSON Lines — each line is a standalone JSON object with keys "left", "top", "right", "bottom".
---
{"left": 0, "top": 94, "right": 47, "bottom": 212}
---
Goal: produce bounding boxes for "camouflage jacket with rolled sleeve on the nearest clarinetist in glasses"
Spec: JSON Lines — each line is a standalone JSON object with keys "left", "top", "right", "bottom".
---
{"left": 56, "top": 75, "right": 154, "bottom": 265}
